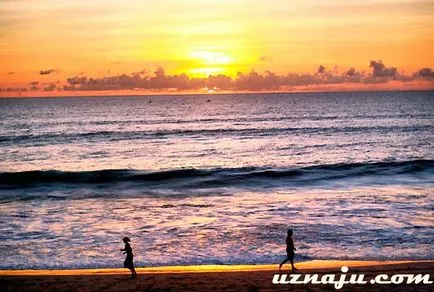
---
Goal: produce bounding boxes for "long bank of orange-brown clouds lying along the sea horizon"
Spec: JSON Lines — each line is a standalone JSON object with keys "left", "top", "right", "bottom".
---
{"left": 1, "top": 61, "right": 434, "bottom": 92}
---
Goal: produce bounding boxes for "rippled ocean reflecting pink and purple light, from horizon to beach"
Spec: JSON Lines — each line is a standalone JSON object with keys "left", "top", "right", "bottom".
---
{"left": 0, "top": 91, "right": 434, "bottom": 269}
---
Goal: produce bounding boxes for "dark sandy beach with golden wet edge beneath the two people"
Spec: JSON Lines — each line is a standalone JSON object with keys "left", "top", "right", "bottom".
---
{"left": 0, "top": 260, "right": 434, "bottom": 291}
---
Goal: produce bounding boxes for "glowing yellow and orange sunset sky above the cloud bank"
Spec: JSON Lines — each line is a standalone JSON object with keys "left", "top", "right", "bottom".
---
{"left": 0, "top": 0, "right": 434, "bottom": 94}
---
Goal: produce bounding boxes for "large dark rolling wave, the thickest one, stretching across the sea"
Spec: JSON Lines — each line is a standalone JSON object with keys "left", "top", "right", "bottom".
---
{"left": 0, "top": 160, "right": 434, "bottom": 189}
